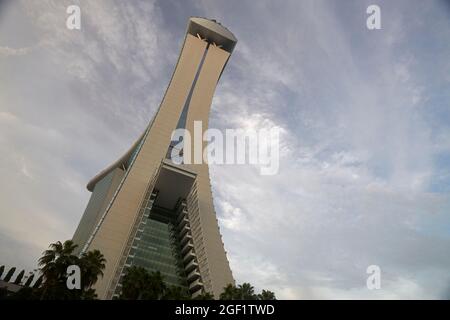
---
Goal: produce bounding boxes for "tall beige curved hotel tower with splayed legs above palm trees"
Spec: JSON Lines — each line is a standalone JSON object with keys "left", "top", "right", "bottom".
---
{"left": 73, "top": 18, "right": 237, "bottom": 299}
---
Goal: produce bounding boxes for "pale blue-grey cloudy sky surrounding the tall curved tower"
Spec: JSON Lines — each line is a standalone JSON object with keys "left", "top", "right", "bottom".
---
{"left": 0, "top": 0, "right": 450, "bottom": 299}
